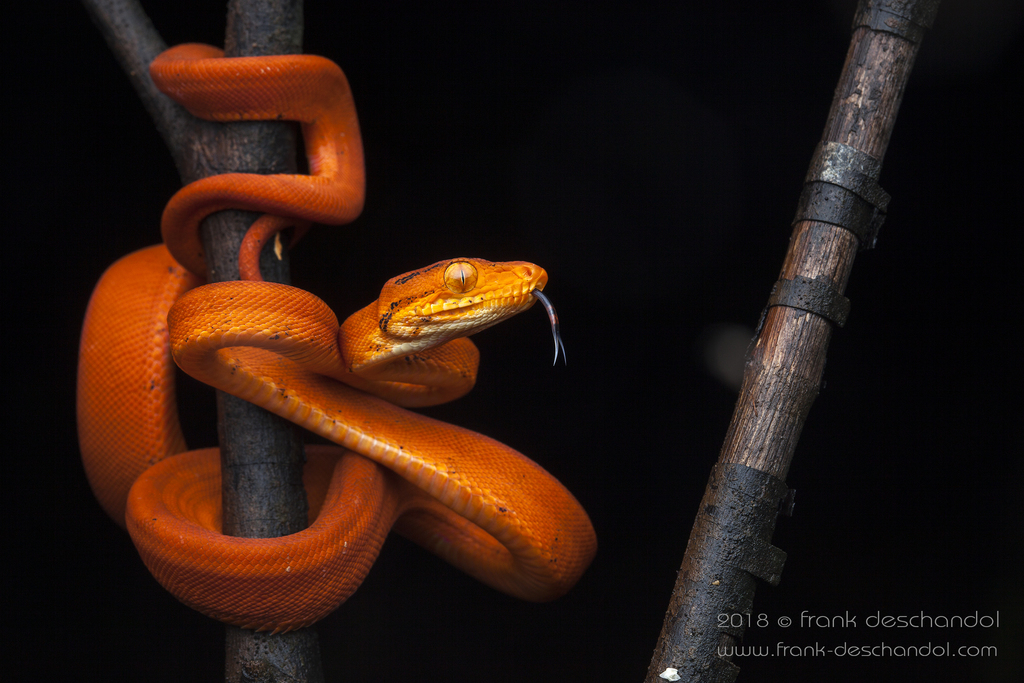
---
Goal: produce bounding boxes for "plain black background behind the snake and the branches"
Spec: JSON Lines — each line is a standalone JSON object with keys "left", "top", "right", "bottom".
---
{"left": 9, "top": 0, "right": 1024, "bottom": 681}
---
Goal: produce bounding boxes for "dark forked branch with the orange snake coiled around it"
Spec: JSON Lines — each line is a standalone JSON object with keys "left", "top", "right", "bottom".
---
{"left": 83, "top": 0, "right": 324, "bottom": 683}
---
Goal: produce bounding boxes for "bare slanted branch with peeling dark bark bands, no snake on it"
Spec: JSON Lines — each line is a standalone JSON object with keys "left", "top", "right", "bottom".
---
{"left": 645, "top": 0, "right": 939, "bottom": 683}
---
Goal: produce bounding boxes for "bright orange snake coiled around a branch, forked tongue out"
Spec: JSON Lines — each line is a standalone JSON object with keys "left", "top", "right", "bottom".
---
{"left": 78, "top": 45, "right": 597, "bottom": 632}
